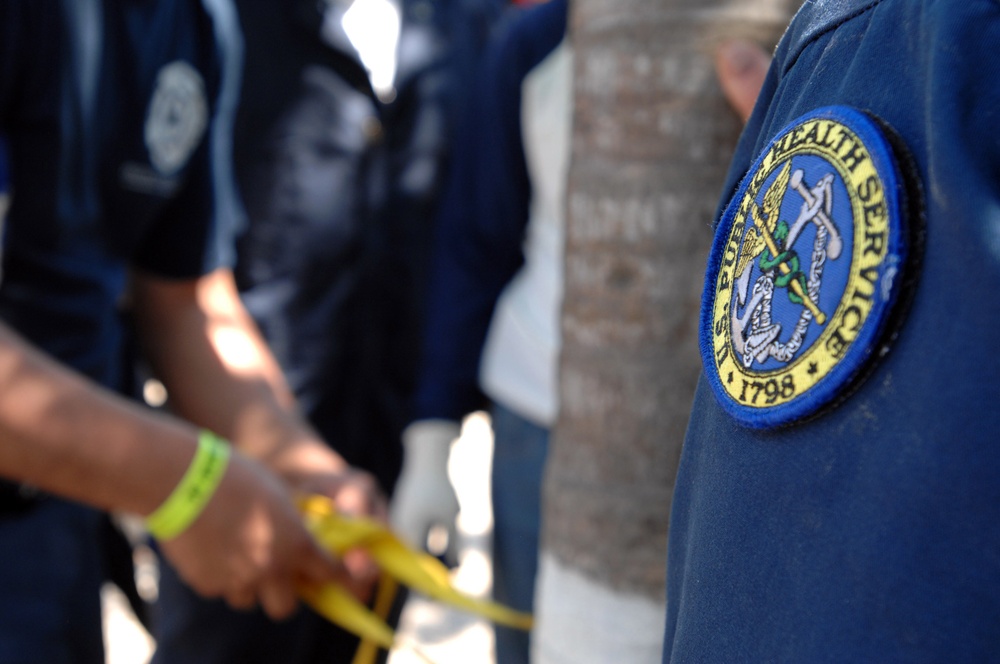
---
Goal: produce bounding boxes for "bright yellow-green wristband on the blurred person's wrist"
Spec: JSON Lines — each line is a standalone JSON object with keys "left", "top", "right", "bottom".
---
{"left": 146, "top": 430, "right": 229, "bottom": 540}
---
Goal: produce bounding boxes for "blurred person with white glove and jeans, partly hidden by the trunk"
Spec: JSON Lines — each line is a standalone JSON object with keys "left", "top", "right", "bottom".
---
{"left": 392, "top": 0, "right": 572, "bottom": 664}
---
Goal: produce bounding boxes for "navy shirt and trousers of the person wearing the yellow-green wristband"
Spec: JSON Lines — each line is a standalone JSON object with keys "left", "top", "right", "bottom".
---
{"left": 0, "top": 0, "right": 226, "bottom": 664}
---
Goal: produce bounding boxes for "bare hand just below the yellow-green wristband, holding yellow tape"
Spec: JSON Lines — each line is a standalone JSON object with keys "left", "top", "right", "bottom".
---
{"left": 160, "top": 451, "right": 349, "bottom": 620}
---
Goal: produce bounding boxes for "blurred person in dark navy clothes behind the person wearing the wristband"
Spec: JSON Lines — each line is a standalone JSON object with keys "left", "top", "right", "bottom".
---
{"left": 154, "top": 0, "right": 502, "bottom": 664}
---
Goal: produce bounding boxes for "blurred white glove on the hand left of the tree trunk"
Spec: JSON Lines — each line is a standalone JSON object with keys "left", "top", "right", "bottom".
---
{"left": 389, "top": 420, "right": 460, "bottom": 549}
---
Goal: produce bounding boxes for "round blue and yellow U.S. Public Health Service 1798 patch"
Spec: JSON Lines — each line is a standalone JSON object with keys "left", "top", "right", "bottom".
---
{"left": 700, "top": 107, "right": 910, "bottom": 428}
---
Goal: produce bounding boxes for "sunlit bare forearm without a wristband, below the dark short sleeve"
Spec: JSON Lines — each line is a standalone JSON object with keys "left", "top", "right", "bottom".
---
{"left": 135, "top": 271, "right": 346, "bottom": 479}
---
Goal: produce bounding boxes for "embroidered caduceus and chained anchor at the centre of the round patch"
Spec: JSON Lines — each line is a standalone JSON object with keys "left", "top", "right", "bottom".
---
{"left": 732, "top": 159, "right": 843, "bottom": 368}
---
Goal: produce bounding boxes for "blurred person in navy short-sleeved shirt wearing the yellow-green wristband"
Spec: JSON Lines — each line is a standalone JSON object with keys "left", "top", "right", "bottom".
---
{"left": 0, "top": 0, "right": 383, "bottom": 664}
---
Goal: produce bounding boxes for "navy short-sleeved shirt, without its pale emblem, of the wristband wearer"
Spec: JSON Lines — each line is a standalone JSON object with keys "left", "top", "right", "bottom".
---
{"left": 0, "top": 0, "right": 230, "bottom": 386}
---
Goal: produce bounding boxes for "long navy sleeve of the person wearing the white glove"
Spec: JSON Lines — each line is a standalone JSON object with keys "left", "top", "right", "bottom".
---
{"left": 415, "top": 0, "right": 568, "bottom": 420}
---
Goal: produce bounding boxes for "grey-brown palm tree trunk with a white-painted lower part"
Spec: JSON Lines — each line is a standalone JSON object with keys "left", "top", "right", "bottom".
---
{"left": 533, "top": 0, "right": 801, "bottom": 664}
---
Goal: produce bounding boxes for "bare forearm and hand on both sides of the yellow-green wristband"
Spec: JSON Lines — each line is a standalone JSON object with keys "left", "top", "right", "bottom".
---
{"left": 0, "top": 324, "right": 346, "bottom": 618}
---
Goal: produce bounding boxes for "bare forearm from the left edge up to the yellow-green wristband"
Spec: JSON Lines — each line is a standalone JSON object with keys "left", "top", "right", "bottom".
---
{"left": 0, "top": 324, "right": 197, "bottom": 515}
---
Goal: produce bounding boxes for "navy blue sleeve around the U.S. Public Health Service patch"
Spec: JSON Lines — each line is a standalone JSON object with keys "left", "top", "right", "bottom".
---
{"left": 664, "top": 0, "right": 1000, "bottom": 662}
